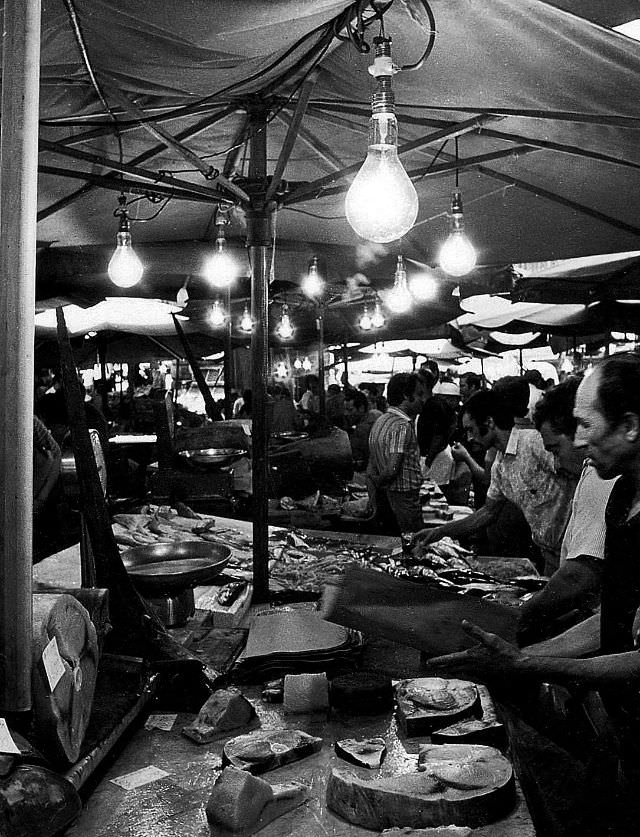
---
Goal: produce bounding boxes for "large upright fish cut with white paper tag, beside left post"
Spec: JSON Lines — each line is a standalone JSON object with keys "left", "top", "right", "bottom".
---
{"left": 32, "top": 593, "right": 98, "bottom": 764}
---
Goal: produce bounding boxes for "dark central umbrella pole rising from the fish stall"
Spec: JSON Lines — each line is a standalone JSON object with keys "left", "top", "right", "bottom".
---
{"left": 247, "top": 102, "right": 273, "bottom": 603}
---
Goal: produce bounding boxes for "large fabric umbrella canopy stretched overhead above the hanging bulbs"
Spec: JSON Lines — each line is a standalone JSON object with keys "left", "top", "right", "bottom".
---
{"left": 28, "top": 0, "right": 640, "bottom": 316}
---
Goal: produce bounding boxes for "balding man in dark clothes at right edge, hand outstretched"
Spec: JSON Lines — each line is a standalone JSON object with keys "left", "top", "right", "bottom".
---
{"left": 430, "top": 354, "right": 640, "bottom": 837}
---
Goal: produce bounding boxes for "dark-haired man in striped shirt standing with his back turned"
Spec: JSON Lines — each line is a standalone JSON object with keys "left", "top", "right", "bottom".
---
{"left": 367, "top": 372, "right": 425, "bottom": 532}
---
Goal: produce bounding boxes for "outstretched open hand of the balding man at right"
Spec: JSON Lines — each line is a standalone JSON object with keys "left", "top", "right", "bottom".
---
{"left": 427, "top": 619, "right": 527, "bottom": 679}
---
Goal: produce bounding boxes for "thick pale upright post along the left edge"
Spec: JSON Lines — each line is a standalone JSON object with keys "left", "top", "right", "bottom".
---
{"left": 0, "top": 0, "right": 40, "bottom": 714}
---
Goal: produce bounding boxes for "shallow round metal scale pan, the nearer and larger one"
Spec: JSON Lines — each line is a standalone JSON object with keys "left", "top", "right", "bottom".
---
{"left": 122, "top": 541, "right": 231, "bottom": 594}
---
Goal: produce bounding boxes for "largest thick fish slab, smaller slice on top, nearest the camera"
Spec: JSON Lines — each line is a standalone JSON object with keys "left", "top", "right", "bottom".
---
{"left": 327, "top": 744, "right": 516, "bottom": 831}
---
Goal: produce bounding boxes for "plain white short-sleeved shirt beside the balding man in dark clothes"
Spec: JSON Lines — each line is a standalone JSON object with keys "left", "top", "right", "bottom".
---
{"left": 560, "top": 463, "right": 617, "bottom": 564}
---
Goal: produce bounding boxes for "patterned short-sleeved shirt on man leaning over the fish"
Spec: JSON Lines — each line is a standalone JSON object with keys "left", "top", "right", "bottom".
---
{"left": 487, "top": 427, "right": 576, "bottom": 555}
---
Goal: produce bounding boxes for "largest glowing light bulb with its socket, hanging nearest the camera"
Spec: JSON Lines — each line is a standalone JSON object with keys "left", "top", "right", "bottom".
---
{"left": 345, "top": 38, "right": 418, "bottom": 244}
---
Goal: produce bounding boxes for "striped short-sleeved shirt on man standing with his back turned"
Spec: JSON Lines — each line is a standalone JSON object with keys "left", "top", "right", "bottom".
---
{"left": 369, "top": 407, "right": 422, "bottom": 492}
